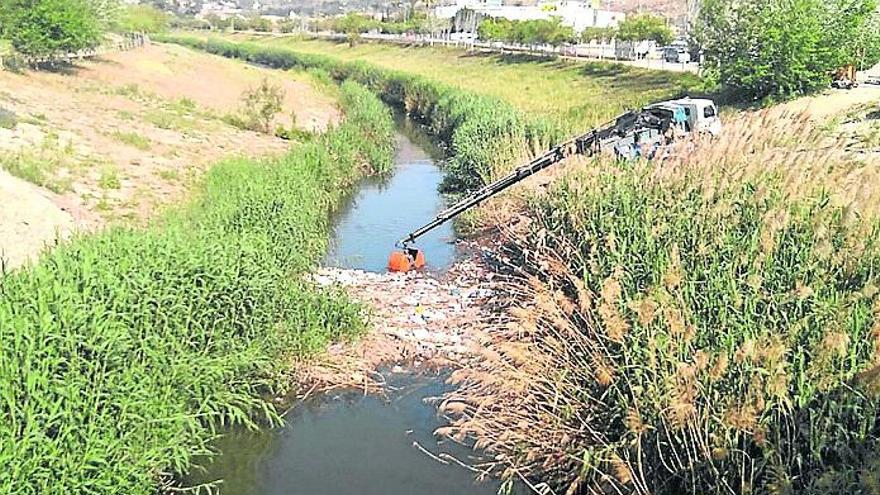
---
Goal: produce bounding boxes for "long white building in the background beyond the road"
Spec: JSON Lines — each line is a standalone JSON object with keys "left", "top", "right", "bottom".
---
{"left": 434, "top": 0, "right": 626, "bottom": 33}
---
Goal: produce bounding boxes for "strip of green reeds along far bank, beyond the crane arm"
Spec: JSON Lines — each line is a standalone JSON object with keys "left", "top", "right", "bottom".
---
{"left": 160, "top": 36, "right": 562, "bottom": 189}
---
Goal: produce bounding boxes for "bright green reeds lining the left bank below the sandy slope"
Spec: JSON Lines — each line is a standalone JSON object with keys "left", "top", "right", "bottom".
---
{"left": 0, "top": 82, "right": 392, "bottom": 494}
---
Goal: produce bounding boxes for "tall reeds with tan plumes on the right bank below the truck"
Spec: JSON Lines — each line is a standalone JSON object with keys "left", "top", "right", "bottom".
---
{"left": 438, "top": 111, "right": 880, "bottom": 494}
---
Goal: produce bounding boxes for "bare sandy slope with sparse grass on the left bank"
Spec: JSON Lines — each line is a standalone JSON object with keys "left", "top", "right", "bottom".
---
{"left": 0, "top": 41, "right": 340, "bottom": 265}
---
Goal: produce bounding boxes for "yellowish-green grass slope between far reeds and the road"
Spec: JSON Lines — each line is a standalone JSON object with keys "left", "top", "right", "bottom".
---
{"left": 228, "top": 35, "right": 703, "bottom": 133}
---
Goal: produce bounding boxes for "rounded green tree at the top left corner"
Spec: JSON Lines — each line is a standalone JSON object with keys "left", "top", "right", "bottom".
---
{"left": 0, "top": 0, "right": 107, "bottom": 57}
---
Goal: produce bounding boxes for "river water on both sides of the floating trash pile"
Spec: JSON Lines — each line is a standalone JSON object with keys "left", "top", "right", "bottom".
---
{"left": 189, "top": 121, "right": 508, "bottom": 495}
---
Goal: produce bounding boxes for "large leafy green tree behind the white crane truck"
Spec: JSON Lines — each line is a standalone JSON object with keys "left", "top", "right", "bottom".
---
{"left": 696, "top": 0, "right": 876, "bottom": 99}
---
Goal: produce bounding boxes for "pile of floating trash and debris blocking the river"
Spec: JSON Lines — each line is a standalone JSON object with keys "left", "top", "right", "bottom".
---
{"left": 300, "top": 252, "right": 496, "bottom": 391}
